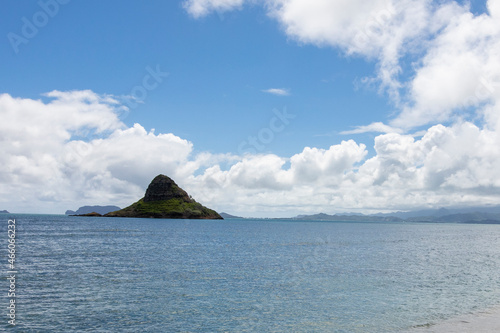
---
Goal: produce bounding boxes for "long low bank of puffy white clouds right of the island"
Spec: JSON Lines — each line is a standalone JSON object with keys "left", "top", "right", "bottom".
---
{"left": 186, "top": 122, "right": 500, "bottom": 216}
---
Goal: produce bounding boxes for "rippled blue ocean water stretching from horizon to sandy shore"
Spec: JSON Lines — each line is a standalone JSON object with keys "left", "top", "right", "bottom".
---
{"left": 0, "top": 215, "right": 500, "bottom": 332}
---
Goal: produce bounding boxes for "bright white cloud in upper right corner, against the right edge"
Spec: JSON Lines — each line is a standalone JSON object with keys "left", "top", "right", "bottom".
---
{"left": 391, "top": 1, "right": 500, "bottom": 128}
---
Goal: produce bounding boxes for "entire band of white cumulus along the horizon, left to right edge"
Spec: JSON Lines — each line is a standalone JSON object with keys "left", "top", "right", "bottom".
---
{"left": 0, "top": 91, "right": 500, "bottom": 216}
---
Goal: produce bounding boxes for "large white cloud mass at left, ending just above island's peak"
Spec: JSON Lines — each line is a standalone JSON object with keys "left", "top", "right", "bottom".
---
{"left": 0, "top": 91, "right": 198, "bottom": 212}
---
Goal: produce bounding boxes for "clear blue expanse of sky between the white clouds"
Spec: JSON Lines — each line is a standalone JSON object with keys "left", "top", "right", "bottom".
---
{"left": 0, "top": 1, "right": 391, "bottom": 155}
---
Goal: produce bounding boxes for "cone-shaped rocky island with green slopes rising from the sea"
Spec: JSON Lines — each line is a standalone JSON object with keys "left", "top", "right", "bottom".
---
{"left": 104, "top": 175, "right": 223, "bottom": 220}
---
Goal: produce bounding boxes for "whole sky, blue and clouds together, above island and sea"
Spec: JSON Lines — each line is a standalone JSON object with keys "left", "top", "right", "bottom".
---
{"left": 0, "top": 0, "right": 500, "bottom": 217}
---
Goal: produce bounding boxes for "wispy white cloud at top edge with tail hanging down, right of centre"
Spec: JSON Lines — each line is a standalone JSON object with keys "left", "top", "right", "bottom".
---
{"left": 268, "top": 0, "right": 456, "bottom": 100}
